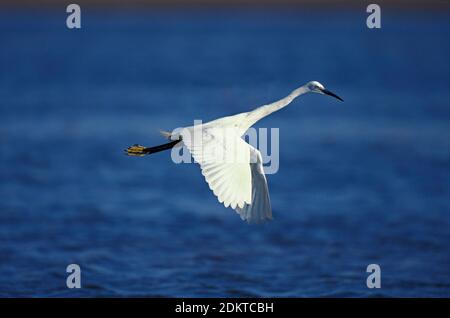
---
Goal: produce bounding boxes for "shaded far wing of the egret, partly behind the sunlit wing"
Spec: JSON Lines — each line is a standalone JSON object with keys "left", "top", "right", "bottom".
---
{"left": 235, "top": 145, "right": 272, "bottom": 223}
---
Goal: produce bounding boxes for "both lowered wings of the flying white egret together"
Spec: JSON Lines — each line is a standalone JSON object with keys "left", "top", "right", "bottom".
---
{"left": 180, "top": 125, "right": 272, "bottom": 223}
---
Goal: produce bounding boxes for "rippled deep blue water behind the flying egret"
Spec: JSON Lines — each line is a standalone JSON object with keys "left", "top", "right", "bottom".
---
{"left": 0, "top": 9, "right": 450, "bottom": 297}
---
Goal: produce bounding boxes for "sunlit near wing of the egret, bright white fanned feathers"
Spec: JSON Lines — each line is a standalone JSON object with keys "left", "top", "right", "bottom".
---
{"left": 180, "top": 125, "right": 252, "bottom": 209}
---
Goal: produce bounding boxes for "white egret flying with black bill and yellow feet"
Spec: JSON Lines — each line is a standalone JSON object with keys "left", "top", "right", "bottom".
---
{"left": 126, "top": 81, "right": 343, "bottom": 223}
